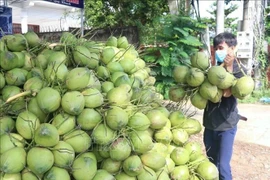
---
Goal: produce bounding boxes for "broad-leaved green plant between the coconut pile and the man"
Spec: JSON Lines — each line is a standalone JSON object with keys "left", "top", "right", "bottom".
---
{"left": 143, "top": 14, "right": 206, "bottom": 99}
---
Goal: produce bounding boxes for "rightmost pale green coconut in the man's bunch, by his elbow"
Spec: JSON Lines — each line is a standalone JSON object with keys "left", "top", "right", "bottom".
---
{"left": 231, "top": 76, "right": 255, "bottom": 99}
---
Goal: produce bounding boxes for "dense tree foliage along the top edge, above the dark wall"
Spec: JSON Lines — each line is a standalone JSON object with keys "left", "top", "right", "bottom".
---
{"left": 85, "top": 0, "right": 169, "bottom": 28}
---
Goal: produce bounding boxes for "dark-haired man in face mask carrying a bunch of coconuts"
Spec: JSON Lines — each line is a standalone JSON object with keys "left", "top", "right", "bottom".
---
{"left": 203, "top": 32, "right": 246, "bottom": 180}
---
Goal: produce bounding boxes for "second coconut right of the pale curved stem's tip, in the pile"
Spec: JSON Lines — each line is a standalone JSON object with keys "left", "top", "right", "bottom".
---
{"left": 61, "top": 91, "right": 85, "bottom": 115}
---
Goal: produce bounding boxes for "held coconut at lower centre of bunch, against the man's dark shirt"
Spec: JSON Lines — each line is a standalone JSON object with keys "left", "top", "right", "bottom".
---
{"left": 199, "top": 79, "right": 218, "bottom": 100}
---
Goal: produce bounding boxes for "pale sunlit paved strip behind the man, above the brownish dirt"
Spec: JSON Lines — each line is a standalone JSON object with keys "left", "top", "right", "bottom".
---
{"left": 194, "top": 104, "right": 270, "bottom": 147}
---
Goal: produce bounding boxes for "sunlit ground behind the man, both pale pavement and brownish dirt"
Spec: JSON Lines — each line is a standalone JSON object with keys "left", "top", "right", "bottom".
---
{"left": 188, "top": 104, "right": 270, "bottom": 180}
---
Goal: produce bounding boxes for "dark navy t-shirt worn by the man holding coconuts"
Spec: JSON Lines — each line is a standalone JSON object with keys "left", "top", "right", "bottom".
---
{"left": 203, "top": 60, "right": 246, "bottom": 131}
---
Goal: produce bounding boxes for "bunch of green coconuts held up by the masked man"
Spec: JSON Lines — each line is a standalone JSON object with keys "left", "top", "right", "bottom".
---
{"left": 169, "top": 51, "right": 255, "bottom": 109}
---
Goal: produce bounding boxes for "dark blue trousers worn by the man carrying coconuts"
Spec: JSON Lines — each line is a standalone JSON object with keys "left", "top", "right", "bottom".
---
{"left": 203, "top": 127, "right": 237, "bottom": 180}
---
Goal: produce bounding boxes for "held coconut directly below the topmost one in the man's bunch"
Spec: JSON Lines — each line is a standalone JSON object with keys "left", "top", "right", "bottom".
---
{"left": 186, "top": 67, "right": 205, "bottom": 87}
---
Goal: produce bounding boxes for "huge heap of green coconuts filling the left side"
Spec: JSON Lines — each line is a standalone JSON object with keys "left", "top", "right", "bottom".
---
{"left": 0, "top": 31, "right": 219, "bottom": 180}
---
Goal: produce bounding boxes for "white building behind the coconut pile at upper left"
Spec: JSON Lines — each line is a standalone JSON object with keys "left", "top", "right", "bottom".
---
{"left": 0, "top": 0, "right": 81, "bottom": 33}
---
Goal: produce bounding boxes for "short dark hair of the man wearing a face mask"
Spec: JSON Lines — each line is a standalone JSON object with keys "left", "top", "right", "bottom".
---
{"left": 213, "top": 32, "right": 237, "bottom": 48}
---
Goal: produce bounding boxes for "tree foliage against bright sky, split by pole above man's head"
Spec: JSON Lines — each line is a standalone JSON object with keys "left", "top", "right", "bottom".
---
{"left": 201, "top": 2, "right": 238, "bottom": 34}
